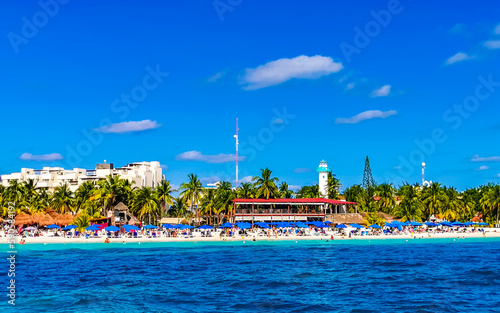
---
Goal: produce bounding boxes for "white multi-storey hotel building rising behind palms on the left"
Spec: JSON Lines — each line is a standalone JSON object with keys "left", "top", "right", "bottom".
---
{"left": 1, "top": 161, "right": 164, "bottom": 192}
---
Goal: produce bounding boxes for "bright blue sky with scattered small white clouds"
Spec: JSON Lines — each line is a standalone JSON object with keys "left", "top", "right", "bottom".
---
{"left": 0, "top": 0, "right": 500, "bottom": 190}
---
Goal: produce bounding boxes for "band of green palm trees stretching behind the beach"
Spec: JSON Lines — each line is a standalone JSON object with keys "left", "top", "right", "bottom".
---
{"left": 0, "top": 168, "right": 500, "bottom": 224}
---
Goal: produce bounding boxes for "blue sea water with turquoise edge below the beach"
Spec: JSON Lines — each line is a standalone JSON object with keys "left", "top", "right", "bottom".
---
{"left": 0, "top": 238, "right": 500, "bottom": 312}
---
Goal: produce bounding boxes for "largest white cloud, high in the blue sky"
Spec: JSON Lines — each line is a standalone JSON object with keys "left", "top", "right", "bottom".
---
{"left": 243, "top": 55, "right": 343, "bottom": 90}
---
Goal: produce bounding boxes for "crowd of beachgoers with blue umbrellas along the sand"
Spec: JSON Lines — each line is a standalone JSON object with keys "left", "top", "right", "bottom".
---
{"left": 2, "top": 221, "right": 494, "bottom": 243}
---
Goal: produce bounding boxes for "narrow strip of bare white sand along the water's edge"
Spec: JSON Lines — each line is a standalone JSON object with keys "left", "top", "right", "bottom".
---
{"left": 0, "top": 231, "right": 500, "bottom": 245}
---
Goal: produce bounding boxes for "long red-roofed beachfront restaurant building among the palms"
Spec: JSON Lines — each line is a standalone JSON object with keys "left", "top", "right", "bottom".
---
{"left": 233, "top": 198, "right": 358, "bottom": 222}
